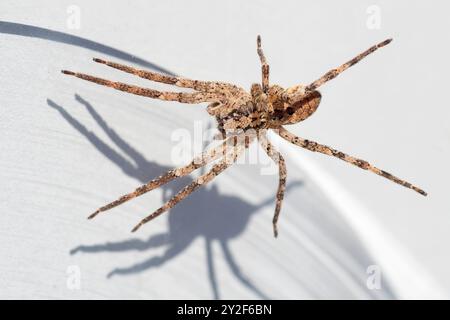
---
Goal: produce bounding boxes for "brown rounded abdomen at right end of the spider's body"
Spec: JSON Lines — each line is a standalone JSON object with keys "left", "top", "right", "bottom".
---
{"left": 279, "top": 85, "right": 322, "bottom": 124}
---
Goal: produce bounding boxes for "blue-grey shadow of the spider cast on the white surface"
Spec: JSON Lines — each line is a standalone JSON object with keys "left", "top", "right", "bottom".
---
{"left": 47, "top": 95, "right": 302, "bottom": 299}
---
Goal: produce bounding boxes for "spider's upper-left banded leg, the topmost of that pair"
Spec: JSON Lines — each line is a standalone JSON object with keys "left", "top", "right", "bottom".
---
{"left": 93, "top": 58, "right": 237, "bottom": 92}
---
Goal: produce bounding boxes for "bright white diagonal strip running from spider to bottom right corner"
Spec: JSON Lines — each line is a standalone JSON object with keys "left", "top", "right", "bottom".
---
{"left": 269, "top": 133, "right": 449, "bottom": 299}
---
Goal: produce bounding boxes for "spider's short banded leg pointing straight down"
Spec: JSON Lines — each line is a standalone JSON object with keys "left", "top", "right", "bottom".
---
{"left": 259, "top": 134, "right": 287, "bottom": 238}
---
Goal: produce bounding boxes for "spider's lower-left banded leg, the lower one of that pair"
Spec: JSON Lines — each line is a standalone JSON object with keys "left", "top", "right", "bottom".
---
{"left": 131, "top": 136, "right": 251, "bottom": 232}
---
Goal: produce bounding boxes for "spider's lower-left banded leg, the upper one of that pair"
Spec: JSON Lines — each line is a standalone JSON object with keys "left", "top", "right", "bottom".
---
{"left": 88, "top": 138, "right": 236, "bottom": 219}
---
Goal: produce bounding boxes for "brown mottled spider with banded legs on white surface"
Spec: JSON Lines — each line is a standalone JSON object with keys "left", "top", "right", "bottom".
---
{"left": 62, "top": 36, "right": 427, "bottom": 237}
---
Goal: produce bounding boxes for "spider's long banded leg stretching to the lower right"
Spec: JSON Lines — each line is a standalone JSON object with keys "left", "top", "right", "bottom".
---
{"left": 277, "top": 127, "right": 427, "bottom": 196}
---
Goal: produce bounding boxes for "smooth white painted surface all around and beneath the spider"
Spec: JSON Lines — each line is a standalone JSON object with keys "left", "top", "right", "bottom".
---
{"left": 0, "top": 1, "right": 450, "bottom": 299}
